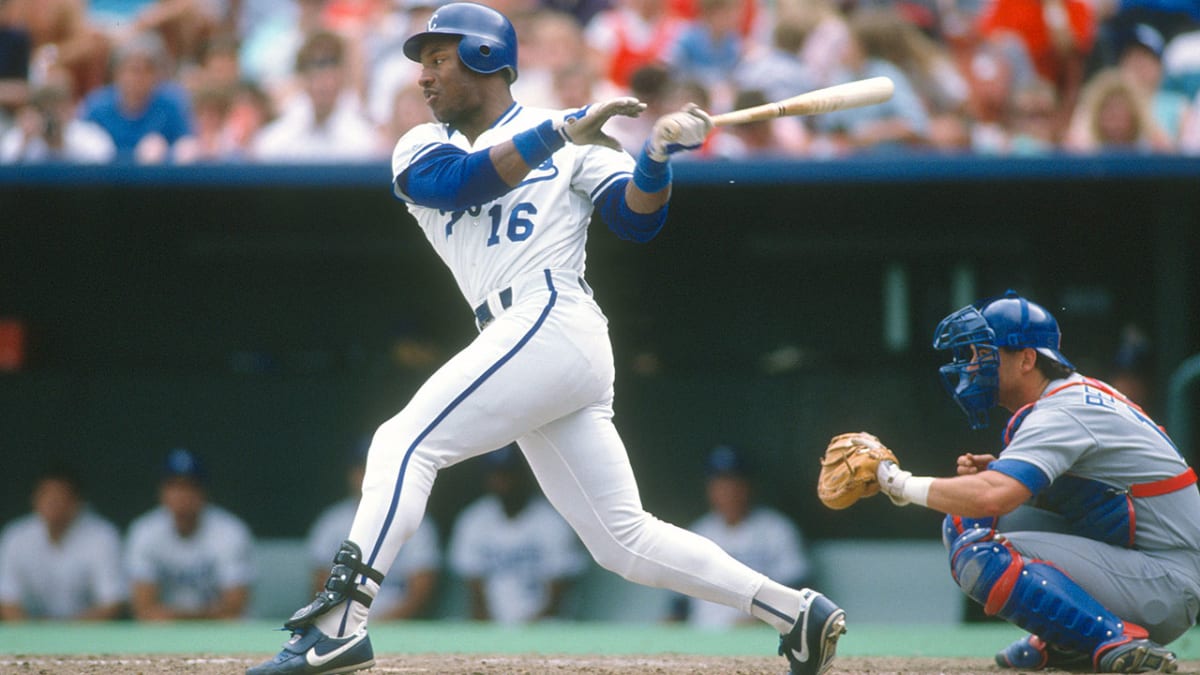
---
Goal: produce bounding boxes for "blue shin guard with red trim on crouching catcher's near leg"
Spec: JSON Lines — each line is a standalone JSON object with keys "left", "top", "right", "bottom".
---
{"left": 950, "top": 527, "right": 1146, "bottom": 655}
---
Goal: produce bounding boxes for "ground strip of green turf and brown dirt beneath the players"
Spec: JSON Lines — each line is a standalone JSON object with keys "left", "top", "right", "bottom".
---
{"left": 0, "top": 621, "right": 1200, "bottom": 675}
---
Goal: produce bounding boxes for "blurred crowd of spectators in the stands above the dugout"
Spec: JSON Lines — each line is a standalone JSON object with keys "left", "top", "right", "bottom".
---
{"left": 0, "top": 0, "right": 1200, "bottom": 165}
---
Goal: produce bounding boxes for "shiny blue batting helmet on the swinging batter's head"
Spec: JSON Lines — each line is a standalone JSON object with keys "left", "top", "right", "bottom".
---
{"left": 404, "top": 2, "right": 517, "bottom": 84}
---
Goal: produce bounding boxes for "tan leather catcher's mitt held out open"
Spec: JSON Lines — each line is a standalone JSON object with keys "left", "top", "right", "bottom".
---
{"left": 817, "top": 431, "right": 900, "bottom": 509}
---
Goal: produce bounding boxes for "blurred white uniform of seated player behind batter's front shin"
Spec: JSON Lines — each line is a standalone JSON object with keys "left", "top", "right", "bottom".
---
{"left": 307, "top": 497, "right": 442, "bottom": 616}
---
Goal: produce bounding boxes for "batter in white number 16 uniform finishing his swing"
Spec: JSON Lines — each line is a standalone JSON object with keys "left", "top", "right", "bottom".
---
{"left": 248, "top": 2, "right": 845, "bottom": 675}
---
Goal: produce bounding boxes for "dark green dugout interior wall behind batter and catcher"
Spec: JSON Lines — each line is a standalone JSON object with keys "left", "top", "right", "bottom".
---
{"left": 0, "top": 161, "right": 1200, "bottom": 537}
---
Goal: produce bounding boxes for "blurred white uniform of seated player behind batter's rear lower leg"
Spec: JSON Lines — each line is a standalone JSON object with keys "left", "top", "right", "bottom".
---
{"left": 688, "top": 506, "right": 810, "bottom": 628}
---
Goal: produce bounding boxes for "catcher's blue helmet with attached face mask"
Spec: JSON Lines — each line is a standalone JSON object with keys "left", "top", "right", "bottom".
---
{"left": 934, "top": 291, "right": 1075, "bottom": 429}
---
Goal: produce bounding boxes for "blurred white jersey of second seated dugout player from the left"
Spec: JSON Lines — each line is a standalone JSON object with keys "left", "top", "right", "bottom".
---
{"left": 125, "top": 504, "right": 254, "bottom": 611}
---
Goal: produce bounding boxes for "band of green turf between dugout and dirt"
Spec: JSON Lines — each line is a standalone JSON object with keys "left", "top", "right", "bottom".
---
{"left": 7, "top": 621, "right": 1200, "bottom": 661}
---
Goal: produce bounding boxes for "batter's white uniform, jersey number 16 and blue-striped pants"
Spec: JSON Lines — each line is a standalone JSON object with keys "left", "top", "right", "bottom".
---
{"left": 349, "top": 103, "right": 766, "bottom": 624}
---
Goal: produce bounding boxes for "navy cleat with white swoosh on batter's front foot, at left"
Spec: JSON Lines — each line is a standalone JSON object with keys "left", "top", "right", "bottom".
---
{"left": 246, "top": 626, "right": 374, "bottom": 675}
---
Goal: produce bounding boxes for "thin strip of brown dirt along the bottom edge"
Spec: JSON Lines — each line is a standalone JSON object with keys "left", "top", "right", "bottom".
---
{"left": 0, "top": 655, "right": 1200, "bottom": 675}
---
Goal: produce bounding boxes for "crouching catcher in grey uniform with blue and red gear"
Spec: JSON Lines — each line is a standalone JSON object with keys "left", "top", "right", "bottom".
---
{"left": 818, "top": 291, "right": 1200, "bottom": 673}
